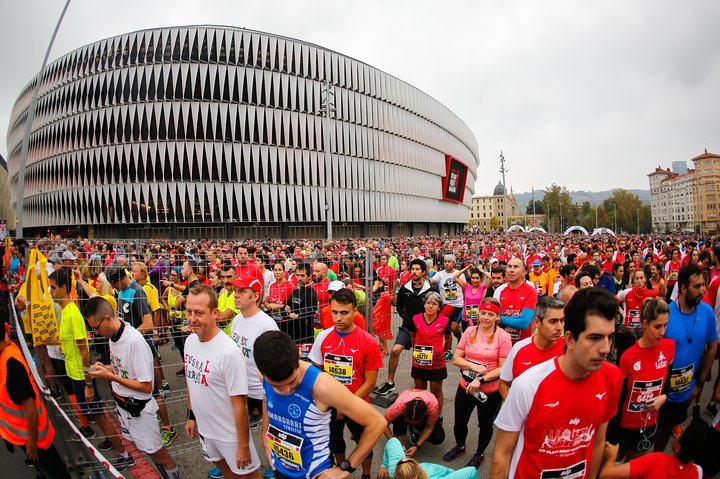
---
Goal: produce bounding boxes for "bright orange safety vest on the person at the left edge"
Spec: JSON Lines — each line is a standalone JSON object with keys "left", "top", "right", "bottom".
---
{"left": 0, "top": 343, "right": 55, "bottom": 449}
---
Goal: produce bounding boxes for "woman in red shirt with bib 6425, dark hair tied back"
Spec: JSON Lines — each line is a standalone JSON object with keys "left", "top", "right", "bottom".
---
{"left": 611, "top": 298, "right": 675, "bottom": 458}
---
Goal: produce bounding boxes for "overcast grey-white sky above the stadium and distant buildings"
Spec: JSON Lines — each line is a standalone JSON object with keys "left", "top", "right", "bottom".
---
{"left": 0, "top": 0, "right": 720, "bottom": 195}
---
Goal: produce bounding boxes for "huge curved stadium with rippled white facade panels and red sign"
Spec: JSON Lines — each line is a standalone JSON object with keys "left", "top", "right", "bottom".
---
{"left": 7, "top": 26, "right": 478, "bottom": 238}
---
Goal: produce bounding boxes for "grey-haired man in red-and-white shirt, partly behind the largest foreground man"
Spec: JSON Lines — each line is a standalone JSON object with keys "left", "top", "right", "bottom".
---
{"left": 499, "top": 296, "right": 565, "bottom": 400}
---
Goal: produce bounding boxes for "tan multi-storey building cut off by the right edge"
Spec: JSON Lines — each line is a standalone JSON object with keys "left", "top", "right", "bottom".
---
{"left": 692, "top": 150, "right": 720, "bottom": 233}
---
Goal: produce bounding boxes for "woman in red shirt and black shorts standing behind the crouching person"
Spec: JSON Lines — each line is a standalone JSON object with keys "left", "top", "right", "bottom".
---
{"left": 408, "top": 291, "right": 452, "bottom": 411}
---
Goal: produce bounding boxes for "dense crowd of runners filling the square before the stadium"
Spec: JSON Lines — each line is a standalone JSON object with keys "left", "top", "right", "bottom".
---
{"left": 0, "top": 233, "right": 720, "bottom": 479}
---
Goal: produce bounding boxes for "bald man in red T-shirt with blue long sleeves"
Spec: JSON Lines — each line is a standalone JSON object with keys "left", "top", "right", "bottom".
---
{"left": 493, "top": 258, "right": 537, "bottom": 344}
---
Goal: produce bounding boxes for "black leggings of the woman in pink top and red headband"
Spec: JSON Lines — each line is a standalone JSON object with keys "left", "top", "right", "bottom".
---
{"left": 453, "top": 385, "right": 500, "bottom": 454}
